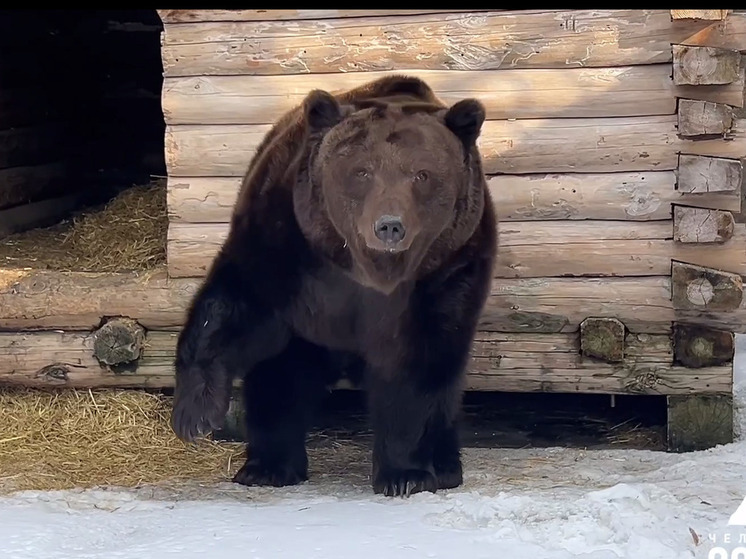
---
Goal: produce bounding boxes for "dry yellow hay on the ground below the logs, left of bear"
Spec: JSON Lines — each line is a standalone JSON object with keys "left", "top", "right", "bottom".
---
{"left": 0, "top": 388, "right": 244, "bottom": 492}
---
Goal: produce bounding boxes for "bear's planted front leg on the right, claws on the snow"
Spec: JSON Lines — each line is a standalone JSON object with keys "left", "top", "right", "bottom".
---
{"left": 369, "top": 258, "right": 492, "bottom": 495}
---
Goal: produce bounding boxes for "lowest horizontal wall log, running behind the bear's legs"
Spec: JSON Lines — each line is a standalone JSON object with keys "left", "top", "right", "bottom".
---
{"left": 0, "top": 332, "right": 732, "bottom": 394}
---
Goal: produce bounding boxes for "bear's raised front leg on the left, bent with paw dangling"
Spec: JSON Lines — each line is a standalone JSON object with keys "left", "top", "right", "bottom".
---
{"left": 171, "top": 256, "right": 290, "bottom": 442}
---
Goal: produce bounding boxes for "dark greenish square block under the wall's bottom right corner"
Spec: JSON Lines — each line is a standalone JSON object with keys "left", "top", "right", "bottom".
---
{"left": 668, "top": 394, "right": 733, "bottom": 452}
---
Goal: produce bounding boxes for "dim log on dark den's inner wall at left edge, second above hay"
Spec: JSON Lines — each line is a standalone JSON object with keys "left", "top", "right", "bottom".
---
{"left": 0, "top": 161, "right": 70, "bottom": 209}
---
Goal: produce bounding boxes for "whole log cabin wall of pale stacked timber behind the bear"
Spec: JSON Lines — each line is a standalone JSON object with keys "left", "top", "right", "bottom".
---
{"left": 0, "top": 10, "right": 746, "bottom": 448}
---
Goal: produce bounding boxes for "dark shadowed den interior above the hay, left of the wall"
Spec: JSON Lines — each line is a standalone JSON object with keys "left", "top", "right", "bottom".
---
{"left": 0, "top": 10, "right": 165, "bottom": 235}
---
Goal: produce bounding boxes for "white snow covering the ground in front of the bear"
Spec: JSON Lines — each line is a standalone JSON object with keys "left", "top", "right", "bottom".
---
{"left": 0, "top": 337, "right": 746, "bottom": 559}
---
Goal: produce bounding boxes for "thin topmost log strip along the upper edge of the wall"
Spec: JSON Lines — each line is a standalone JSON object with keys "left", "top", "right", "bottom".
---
{"left": 157, "top": 10, "right": 474, "bottom": 24}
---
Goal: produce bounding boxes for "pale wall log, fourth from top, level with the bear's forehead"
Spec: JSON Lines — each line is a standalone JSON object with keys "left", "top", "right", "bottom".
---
{"left": 166, "top": 116, "right": 746, "bottom": 177}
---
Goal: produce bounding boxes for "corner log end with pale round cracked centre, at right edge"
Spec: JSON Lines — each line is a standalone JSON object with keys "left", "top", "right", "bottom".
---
{"left": 671, "top": 262, "right": 743, "bottom": 311}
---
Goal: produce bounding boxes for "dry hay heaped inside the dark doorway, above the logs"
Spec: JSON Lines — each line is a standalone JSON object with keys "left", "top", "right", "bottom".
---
{"left": 0, "top": 180, "right": 168, "bottom": 272}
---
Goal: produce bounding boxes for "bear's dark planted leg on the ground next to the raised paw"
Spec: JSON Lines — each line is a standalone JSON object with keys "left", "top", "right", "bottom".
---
{"left": 233, "top": 338, "right": 334, "bottom": 487}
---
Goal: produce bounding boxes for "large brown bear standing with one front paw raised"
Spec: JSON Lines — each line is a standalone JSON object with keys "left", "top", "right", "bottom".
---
{"left": 172, "top": 76, "right": 497, "bottom": 495}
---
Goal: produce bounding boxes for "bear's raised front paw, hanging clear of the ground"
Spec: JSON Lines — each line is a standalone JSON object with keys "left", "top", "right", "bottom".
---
{"left": 171, "top": 385, "right": 230, "bottom": 442}
